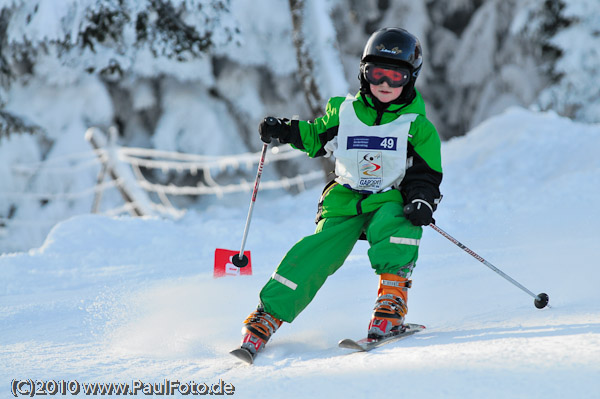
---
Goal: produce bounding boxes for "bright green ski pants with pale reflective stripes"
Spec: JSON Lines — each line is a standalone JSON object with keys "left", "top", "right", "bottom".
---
{"left": 260, "top": 202, "right": 423, "bottom": 323}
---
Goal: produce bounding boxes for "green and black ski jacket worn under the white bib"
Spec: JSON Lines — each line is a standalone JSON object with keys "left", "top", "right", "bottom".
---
{"left": 290, "top": 89, "right": 442, "bottom": 219}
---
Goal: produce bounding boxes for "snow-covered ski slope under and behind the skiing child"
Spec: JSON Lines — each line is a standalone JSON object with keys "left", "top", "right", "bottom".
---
{"left": 0, "top": 109, "right": 600, "bottom": 399}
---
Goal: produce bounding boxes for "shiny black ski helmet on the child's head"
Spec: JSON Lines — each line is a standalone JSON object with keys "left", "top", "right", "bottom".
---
{"left": 358, "top": 28, "right": 423, "bottom": 103}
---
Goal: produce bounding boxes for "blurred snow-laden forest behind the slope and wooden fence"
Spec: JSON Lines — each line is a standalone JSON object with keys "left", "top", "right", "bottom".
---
{"left": 0, "top": 0, "right": 600, "bottom": 252}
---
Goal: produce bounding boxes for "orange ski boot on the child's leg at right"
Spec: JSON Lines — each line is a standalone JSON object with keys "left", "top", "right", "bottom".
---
{"left": 368, "top": 273, "right": 412, "bottom": 339}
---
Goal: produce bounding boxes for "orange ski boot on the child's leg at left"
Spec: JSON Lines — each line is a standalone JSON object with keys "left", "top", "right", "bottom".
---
{"left": 231, "top": 307, "right": 283, "bottom": 364}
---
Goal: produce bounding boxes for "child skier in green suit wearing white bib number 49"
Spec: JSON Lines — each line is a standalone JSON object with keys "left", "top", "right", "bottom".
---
{"left": 241, "top": 28, "right": 442, "bottom": 357}
